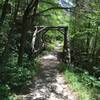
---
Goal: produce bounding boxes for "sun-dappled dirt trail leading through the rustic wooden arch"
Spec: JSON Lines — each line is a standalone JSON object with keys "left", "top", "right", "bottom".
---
{"left": 16, "top": 43, "right": 77, "bottom": 100}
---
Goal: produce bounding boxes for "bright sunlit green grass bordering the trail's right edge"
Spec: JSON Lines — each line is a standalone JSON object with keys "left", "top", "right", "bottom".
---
{"left": 60, "top": 64, "right": 100, "bottom": 100}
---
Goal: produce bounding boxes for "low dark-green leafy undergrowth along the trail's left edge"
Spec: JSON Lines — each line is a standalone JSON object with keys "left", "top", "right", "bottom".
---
{"left": 0, "top": 57, "right": 41, "bottom": 100}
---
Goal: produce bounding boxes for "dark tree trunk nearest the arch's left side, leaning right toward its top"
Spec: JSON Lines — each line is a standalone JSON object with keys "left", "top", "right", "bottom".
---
{"left": 18, "top": 0, "right": 38, "bottom": 65}
